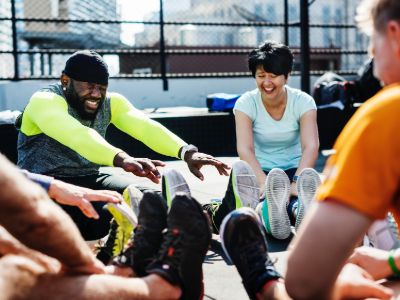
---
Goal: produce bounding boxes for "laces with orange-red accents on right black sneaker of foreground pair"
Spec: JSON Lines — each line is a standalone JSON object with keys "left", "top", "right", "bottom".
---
{"left": 158, "top": 229, "right": 183, "bottom": 268}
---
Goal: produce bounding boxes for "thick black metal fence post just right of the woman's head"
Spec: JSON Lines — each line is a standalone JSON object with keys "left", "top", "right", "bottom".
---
{"left": 300, "top": 0, "right": 310, "bottom": 93}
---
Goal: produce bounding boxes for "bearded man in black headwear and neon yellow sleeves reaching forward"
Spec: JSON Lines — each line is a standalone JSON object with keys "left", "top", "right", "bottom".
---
{"left": 17, "top": 50, "right": 229, "bottom": 255}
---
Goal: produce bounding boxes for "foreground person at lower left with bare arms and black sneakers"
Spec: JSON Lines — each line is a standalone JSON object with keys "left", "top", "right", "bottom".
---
{"left": 0, "top": 155, "right": 211, "bottom": 299}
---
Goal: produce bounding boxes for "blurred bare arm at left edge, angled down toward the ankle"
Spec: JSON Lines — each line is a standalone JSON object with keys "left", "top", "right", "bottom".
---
{"left": 0, "top": 155, "right": 104, "bottom": 273}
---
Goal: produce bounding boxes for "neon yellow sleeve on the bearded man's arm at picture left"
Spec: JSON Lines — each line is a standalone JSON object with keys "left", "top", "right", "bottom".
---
{"left": 21, "top": 92, "right": 122, "bottom": 166}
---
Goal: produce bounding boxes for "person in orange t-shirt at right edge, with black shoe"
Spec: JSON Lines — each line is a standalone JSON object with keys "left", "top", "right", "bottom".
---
{"left": 221, "top": 0, "right": 400, "bottom": 299}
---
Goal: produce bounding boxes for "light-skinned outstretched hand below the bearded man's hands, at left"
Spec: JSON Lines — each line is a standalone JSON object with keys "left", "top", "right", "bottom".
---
{"left": 49, "top": 180, "right": 123, "bottom": 219}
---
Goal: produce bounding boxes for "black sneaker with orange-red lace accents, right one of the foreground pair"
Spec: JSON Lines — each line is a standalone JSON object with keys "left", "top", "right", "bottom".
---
{"left": 147, "top": 193, "right": 211, "bottom": 300}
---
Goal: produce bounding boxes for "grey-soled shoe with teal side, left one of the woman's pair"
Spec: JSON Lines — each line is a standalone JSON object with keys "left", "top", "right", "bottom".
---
{"left": 256, "top": 168, "right": 291, "bottom": 240}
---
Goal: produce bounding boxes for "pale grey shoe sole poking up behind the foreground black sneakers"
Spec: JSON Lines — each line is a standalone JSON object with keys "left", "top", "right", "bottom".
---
{"left": 161, "top": 169, "right": 190, "bottom": 207}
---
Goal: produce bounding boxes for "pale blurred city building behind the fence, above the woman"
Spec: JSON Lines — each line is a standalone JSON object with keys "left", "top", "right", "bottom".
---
{"left": 129, "top": 0, "right": 368, "bottom": 73}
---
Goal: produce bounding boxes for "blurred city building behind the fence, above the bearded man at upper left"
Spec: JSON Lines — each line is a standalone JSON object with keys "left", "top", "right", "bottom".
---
{"left": 20, "top": 0, "right": 121, "bottom": 75}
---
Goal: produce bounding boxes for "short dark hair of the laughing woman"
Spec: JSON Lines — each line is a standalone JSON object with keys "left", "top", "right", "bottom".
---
{"left": 248, "top": 41, "right": 293, "bottom": 78}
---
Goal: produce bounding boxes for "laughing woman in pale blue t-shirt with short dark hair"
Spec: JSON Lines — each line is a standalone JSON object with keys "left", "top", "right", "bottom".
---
{"left": 203, "top": 41, "right": 319, "bottom": 239}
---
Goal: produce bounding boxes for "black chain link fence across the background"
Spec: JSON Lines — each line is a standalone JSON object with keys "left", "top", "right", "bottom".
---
{"left": 0, "top": 0, "right": 368, "bottom": 86}
